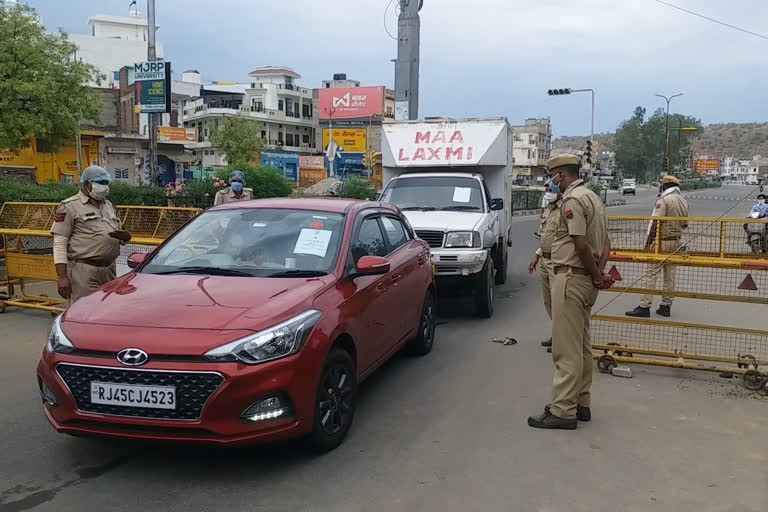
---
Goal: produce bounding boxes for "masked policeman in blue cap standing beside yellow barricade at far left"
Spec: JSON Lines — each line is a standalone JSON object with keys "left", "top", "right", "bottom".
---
{"left": 51, "top": 165, "right": 131, "bottom": 304}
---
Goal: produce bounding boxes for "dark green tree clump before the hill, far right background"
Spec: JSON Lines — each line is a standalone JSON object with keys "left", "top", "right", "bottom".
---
{"left": 614, "top": 107, "right": 702, "bottom": 181}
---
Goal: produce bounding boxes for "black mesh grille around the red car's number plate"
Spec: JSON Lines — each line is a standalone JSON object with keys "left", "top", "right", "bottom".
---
{"left": 56, "top": 363, "right": 224, "bottom": 420}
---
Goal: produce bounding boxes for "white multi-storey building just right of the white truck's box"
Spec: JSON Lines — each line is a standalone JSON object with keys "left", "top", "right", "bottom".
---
{"left": 512, "top": 117, "right": 552, "bottom": 184}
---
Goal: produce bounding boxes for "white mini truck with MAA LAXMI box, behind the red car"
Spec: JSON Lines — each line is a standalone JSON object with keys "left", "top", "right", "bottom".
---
{"left": 381, "top": 118, "right": 513, "bottom": 317}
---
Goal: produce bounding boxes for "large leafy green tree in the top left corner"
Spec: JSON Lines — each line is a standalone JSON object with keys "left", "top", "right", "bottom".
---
{"left": 0, "top": 4, "right": 102, "bottom": 152}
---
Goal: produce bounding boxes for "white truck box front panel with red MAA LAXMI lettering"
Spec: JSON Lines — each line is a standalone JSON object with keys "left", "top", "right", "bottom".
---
{"left": 382, "top": 121, "right": 508, "bottom": 167}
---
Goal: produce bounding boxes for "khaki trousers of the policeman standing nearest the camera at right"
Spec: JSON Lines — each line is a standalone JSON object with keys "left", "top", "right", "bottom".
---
{"left": 551, "top": 270, "right": 597, "bottom": 419}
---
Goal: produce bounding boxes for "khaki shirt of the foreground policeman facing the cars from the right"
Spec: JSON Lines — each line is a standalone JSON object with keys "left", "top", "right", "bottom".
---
{"left": 542, "top": 180, "right": 608, "bottom": 268}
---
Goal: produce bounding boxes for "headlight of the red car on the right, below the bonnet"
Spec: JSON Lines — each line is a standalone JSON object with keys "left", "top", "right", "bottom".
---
{"left": 205, "top": 309, "right": 322, "bottom": 364}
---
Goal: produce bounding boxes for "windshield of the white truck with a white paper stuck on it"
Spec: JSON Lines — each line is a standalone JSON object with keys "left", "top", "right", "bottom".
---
{"left": 381, "top": 176, "right": 484, "bottom": 212}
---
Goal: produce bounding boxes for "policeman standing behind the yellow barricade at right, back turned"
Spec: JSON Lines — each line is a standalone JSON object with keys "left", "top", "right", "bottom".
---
{"left": 627, "top": 176, "right": 688, "bottom": 318}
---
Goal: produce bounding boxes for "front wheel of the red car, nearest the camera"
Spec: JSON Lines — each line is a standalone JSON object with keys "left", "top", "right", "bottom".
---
{"left": 307, "top": 348, "right": 357, "bottom": 453}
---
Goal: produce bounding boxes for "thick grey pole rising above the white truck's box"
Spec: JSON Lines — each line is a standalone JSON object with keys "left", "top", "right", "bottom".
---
{"left": 395, "top": 0, "right": 423, "bottom": 121}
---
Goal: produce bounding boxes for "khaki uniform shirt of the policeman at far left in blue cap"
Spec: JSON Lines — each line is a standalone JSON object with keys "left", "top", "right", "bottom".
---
{"left": 51, "top": 191, "right": 122, "bottom": 265}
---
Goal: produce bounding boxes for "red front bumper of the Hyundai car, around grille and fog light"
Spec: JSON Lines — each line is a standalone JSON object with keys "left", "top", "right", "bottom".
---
{"left": 37, "top": 352, "right": 322, "bottom": 444}
